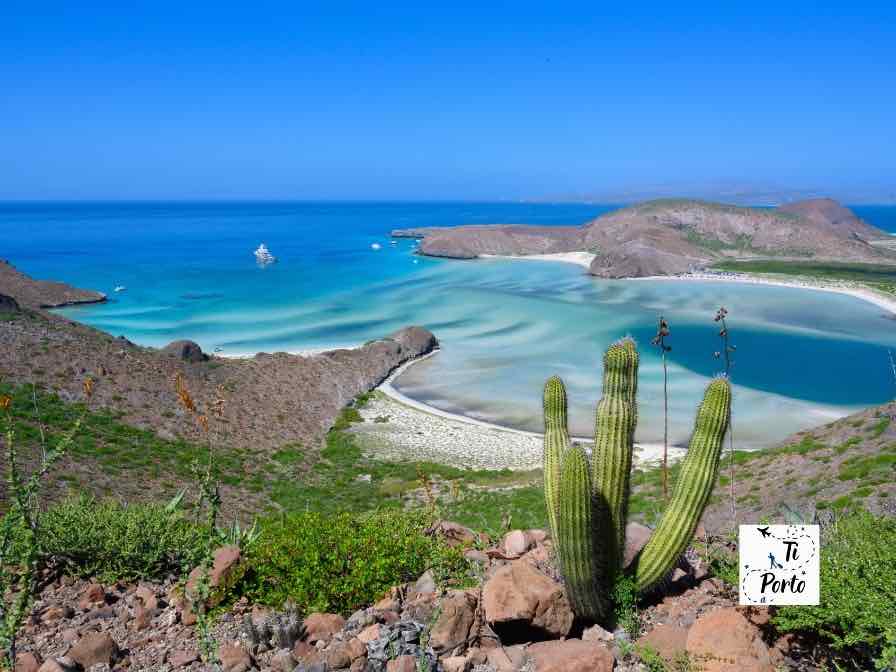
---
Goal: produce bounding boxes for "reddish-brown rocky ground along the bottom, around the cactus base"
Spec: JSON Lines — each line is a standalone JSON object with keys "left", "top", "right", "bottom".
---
{"left": 16, "top": 522, "right": 800, "bottom": 672}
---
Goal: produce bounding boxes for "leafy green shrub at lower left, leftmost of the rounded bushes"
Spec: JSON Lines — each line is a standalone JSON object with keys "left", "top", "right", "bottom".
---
{"left": 38, "top": 497, "right": 205, "bottom": 582}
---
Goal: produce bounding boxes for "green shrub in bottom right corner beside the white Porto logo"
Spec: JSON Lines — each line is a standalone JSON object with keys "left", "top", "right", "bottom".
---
{"left": 774, "top": 511, "right": 896, "bottom": 669}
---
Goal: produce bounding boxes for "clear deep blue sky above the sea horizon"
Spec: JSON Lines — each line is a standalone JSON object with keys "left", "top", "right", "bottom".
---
{"left": 0, "top": 0, "right": 896, "bottom": 199}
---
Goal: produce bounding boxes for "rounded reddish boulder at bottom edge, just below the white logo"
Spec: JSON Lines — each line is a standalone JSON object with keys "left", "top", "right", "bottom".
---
{"left": 686, "top": 607, "right": 775, "bottom": 672}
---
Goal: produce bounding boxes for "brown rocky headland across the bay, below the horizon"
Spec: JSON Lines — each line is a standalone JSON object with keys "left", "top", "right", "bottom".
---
{"left": 392, "top": 199, "right": 896, "bottom": 278}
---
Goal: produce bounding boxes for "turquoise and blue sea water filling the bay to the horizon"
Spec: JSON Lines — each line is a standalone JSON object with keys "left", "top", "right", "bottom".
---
{"left": 0, "top": 203, "right": 896, "bottom": 447}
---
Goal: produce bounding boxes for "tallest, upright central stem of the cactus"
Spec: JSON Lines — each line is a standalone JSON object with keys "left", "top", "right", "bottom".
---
{"left": 592, "top": 338, "right": 638, "bottom": 582}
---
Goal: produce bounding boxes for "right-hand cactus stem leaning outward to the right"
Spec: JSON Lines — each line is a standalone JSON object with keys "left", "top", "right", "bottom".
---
{"left": 632, "top": 377, "right": 731, "bottom": 592}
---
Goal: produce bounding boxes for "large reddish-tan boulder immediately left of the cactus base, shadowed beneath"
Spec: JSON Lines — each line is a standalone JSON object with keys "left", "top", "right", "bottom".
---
{"left": 482, "top": 560, "right": 574, "bottom": 643}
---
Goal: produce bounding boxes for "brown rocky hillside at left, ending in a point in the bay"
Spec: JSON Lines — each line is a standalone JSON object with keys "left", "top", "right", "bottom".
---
{"left": 0, "top": 265, "right": 438, "bottom": 450}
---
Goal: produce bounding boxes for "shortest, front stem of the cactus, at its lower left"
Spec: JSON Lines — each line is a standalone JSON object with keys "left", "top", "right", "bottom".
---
{"left": 558, "top": 446, "right": 609, "bottom": 620}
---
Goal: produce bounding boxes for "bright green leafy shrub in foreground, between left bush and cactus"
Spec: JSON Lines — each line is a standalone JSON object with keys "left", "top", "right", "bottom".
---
{"left": 237, "top": 510, "right": 467, "bottom": 614}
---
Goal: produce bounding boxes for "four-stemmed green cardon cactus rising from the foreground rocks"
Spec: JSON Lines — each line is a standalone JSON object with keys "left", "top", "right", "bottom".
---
{"left": 544, "top": 338, "right": 731, "bottom": 621}
